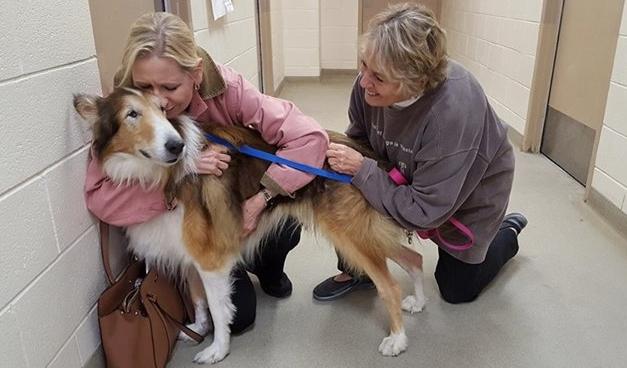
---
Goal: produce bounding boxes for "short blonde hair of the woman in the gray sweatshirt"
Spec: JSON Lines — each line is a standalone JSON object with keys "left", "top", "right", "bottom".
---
{"left": 360, "top": 4, "right": 447, "bottom": 96}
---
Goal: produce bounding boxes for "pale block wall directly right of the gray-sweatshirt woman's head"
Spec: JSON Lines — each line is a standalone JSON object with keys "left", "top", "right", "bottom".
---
{"left": 441, "top": 0, "right": 543, "bottom": 134}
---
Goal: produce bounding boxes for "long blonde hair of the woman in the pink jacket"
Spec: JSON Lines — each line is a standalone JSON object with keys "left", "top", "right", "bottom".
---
{"left": 114, "top": 12, "right": 206, "bottom": 87}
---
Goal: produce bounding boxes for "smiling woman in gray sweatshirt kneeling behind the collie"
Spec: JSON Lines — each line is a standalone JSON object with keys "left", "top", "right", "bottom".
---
{"left": 313, "top": 4, "right": 527, "bottom": 303}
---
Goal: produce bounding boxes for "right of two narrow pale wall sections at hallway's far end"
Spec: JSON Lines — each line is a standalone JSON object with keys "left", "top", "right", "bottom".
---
{"left": 320, "top": 0, "right": 359, "bottom": 69}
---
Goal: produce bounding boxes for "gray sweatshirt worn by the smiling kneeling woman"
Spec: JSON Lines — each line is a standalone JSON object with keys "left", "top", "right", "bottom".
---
{"left": 346, "top": 61, "right": 514, "bottom": 263}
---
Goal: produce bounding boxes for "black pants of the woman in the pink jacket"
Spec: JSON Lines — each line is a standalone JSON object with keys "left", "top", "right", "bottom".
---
{"left": 231, "top": 218, "right": 301, "bottom": 334}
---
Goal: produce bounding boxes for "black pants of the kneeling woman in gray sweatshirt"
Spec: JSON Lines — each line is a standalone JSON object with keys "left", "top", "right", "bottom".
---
{"left": 337, "top": 228, "right": 518, "bottom": 304}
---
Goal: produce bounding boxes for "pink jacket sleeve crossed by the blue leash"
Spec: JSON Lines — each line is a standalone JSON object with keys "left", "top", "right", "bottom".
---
{"left": 226, "top": 69, "right": 329, "bottom": 195}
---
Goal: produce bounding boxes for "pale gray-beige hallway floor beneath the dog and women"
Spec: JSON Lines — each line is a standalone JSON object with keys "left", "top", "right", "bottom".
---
{"left": 88, "top": 77, "right": 627, "bottom": 368}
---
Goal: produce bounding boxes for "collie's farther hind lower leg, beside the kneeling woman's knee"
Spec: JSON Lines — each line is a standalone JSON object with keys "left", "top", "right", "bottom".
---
{"left": 390, "top": 246, "right": 426, "bottom": 313}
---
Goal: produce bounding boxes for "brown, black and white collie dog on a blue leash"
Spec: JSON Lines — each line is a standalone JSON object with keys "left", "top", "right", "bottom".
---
{"left": 74, "top": 88, "right": 425, "bottom": 363}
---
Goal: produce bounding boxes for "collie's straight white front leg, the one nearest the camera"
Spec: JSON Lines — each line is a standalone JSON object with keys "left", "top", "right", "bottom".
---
{"left": 194, "top": 266, "right": 235, "bottom": 364}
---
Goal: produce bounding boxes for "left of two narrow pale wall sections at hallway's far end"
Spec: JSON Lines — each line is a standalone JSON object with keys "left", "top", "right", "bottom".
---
{"left": 282, "top": 0, "right": 320, "bottom": 77}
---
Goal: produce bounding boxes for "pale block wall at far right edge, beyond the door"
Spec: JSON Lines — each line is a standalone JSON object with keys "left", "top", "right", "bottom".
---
{"left": 592, "top": 3, "right": 627, "bottom": 214}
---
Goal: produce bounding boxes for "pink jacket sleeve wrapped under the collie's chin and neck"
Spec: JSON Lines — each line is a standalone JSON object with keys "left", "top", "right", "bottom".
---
{"left": 85, "top": 152, "right": 167, "bottom": 226}
